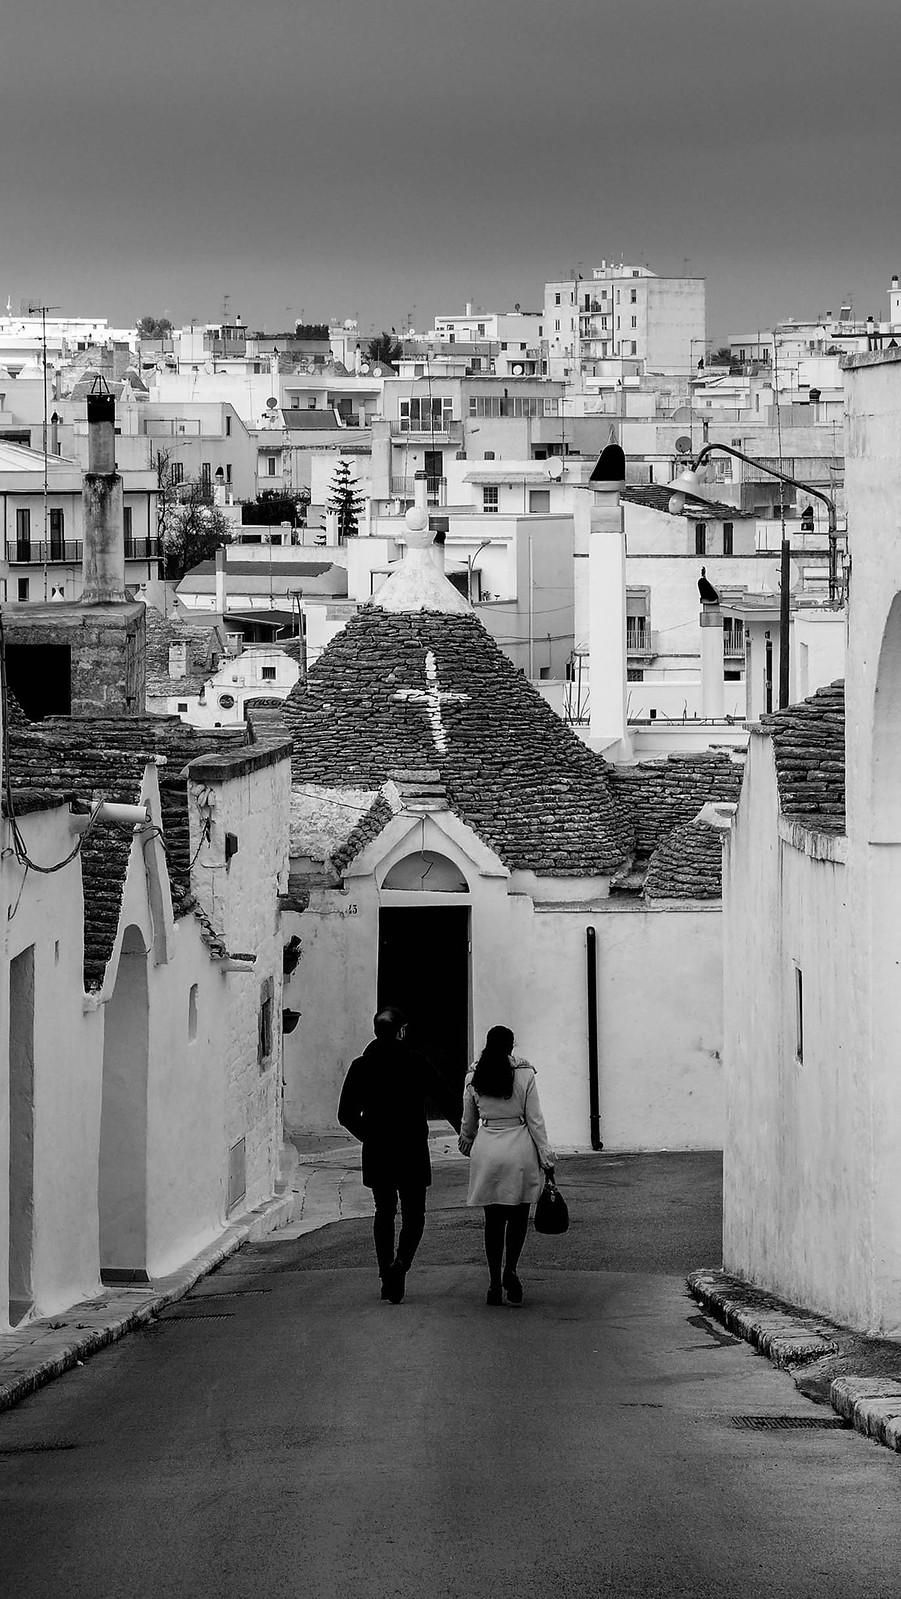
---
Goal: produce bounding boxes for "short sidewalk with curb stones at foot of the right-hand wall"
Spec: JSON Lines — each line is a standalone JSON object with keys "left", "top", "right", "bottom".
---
{"left": 688, "top": 1270, "right": 901, "bottom": 1453}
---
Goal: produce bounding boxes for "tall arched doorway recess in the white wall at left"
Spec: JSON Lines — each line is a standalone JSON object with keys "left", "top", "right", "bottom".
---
{"left": 98, "top": 926, "right": 149, "bottom": 1282}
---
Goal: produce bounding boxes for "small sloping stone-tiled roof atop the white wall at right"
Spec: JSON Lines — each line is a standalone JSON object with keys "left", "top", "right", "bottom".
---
{"left": 760, "top": 681, "right": 845, "bottom": 833}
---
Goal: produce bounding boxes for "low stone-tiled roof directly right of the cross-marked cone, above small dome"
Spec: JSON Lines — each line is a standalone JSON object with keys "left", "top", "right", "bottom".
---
{"left": 611, "top": 750, "right": 744, "bottom": 860}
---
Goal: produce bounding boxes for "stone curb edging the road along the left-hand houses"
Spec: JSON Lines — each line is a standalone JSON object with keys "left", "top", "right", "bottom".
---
{"left": 0, "top": 1194, "right": 294, "bottom": 1412}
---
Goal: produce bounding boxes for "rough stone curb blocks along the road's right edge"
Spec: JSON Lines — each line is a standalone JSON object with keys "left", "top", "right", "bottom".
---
{"left": 687, "top": 1271, "right": 901, "bottom": 1453}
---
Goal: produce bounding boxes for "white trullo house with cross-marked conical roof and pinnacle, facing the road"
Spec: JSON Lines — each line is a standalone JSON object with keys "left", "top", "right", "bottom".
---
{"left": 285, "top": 512, "right": 739, "bottom": 1148}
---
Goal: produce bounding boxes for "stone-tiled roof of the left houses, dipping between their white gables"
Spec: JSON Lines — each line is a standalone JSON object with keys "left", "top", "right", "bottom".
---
{"left": 10, "top": 716, "right": 248, "bottom": 988}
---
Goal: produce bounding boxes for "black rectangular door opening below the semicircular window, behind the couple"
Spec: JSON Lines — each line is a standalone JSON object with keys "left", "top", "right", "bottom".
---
{"left": 378, "top": 905, "right": 469, "bottom": 1116}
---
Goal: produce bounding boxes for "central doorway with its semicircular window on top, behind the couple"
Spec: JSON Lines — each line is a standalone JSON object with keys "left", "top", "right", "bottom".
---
{"left": 378, "top": 849, "right": 471, "bottom": 1115}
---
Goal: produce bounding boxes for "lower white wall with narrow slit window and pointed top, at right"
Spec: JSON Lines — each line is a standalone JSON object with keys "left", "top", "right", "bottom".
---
{"left": 723, "top": 732, "right": 874, "bottom": 1326}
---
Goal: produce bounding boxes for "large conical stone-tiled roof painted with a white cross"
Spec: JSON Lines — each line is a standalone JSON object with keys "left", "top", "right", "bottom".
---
{"left": 285, "top": 608, "right": 633, "bottom": 876}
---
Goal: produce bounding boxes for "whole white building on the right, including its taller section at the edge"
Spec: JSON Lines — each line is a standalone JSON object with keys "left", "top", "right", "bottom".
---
{"left": 725, "top": 349, "right": 901, "bottom": 1337}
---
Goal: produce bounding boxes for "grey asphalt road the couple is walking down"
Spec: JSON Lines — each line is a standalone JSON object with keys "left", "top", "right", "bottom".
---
{"left": 0, "top": 1156, "right": 901, "bottom": 1599}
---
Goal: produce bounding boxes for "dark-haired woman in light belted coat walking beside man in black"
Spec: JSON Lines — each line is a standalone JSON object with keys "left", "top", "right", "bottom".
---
{"left": 459, "top": 1027, "right": 557, "bottom": 1305}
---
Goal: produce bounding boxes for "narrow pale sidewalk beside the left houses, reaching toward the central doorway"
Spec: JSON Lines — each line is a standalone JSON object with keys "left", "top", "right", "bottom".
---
{"left": 0, "top": 1132, "right": 463, "bottom": 1410}
